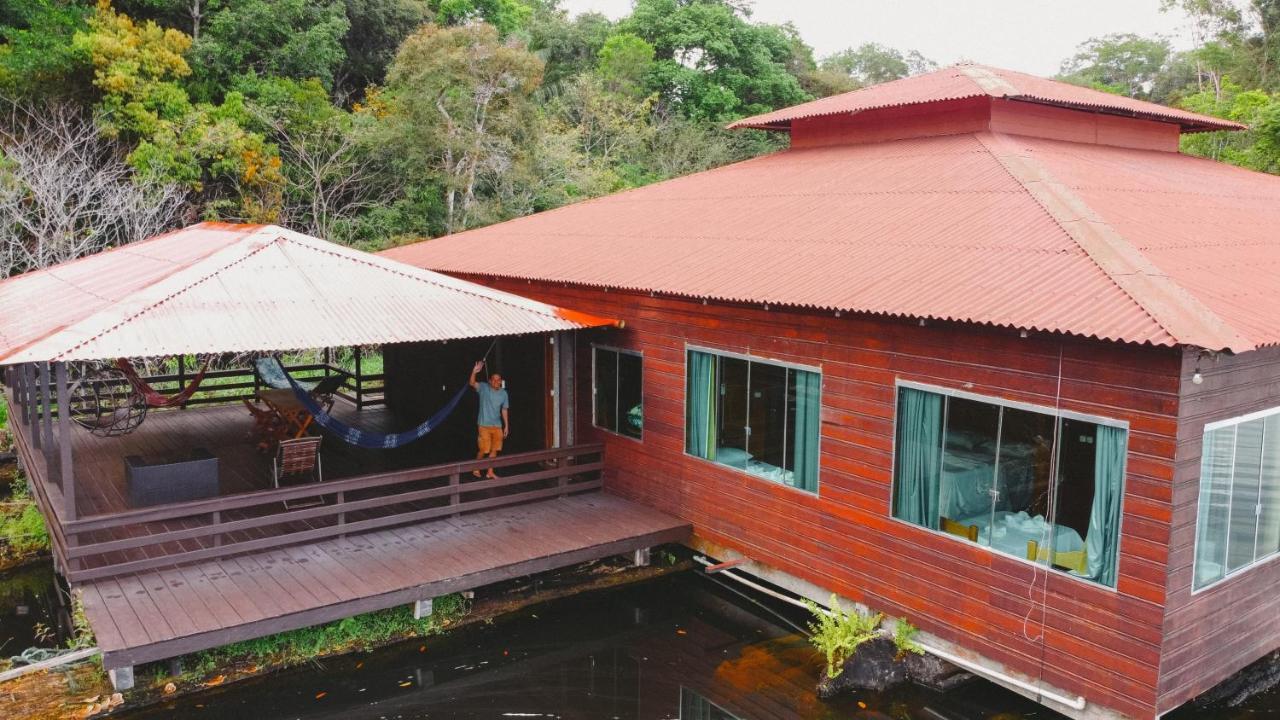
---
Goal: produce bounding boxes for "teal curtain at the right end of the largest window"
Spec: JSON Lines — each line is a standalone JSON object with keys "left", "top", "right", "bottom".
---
{"left": 1084, "top": 425, "right": 1129, "bottom": 587}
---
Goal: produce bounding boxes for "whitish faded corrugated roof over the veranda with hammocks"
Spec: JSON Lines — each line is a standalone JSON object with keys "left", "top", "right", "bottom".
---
{"left": 0, "top": 223, "right": 613, "bottom": 364}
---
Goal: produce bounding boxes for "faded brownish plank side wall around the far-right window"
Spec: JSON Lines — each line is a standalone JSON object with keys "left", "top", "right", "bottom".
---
{"left": 1160, "top": 347, "right": 1280, "bottom": 711}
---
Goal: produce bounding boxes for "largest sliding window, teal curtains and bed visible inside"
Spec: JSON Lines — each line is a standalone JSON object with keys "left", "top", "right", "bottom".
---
{"left": 892, "top": 387, "right": 1128, "bottom": 587}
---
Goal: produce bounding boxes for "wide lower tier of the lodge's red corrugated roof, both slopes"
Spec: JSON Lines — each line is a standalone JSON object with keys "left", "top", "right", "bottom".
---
{"left": 385, "top": 125, "right": 1280, "bottom": 351}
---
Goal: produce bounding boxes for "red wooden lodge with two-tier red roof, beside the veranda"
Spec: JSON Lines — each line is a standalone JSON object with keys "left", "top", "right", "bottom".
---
{"left": 384, "top": 65, "right": 1280, "bottom": 719}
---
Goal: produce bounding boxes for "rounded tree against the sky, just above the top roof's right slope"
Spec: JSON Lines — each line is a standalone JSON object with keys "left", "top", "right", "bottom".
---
{"left": 1059, "top": 33, "right": 1172, "bottom": 100}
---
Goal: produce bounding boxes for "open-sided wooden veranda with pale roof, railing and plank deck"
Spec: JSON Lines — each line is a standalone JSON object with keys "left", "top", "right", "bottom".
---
{"left": 0, "top": 223, "right": 687, "bottom": 669}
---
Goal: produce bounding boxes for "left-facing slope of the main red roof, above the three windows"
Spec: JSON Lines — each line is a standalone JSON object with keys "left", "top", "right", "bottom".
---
{"left": 385, "top": 135, "right": 1198, "bottom": 345}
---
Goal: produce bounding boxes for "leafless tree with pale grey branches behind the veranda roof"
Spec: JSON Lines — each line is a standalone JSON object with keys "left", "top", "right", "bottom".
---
{"left": 0, "top": 100, "right": 184, "bottom": 278}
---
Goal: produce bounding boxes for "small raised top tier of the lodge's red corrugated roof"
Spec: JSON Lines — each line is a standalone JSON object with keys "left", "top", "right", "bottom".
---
{"left": 728, "top": 64, "right": 1244, "bottom": 132}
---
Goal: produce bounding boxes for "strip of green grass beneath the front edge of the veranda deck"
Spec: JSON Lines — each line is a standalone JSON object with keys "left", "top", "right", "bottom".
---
{"left": 177, "top": 594, "right": 470, "bottom": 678}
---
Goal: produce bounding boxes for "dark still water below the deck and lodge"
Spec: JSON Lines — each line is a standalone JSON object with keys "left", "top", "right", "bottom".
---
{"left": 0, "top": 569, "right": 1280, "bottom": 720}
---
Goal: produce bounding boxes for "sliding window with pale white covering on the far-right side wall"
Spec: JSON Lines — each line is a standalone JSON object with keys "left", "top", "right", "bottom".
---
{"left": 1193, "top": 407, "right": 1280, "bottom": 589}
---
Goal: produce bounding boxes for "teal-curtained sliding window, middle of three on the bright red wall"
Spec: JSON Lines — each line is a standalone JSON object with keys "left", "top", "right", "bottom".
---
{"left": 685, "top": 350, "right": 822, "bottom": 492}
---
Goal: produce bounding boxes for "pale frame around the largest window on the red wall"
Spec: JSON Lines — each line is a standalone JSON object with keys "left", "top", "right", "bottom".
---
{"left": 888, "top": 378, "right": 1130, "bottom": 593}
